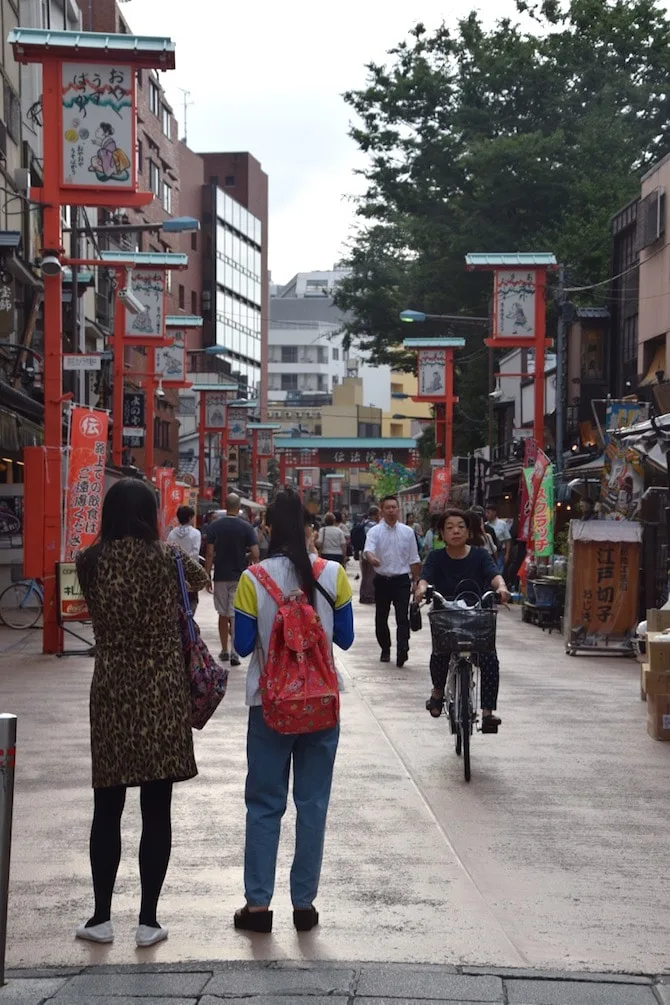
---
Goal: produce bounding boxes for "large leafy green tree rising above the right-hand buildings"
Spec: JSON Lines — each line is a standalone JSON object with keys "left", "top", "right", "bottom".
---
{"left": 337, "top": 0, "right": 670, "bottom": 448}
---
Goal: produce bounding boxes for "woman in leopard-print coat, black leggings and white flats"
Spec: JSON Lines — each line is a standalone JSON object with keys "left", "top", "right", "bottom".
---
{"left": 76, "top": 478, "right": 209, "bottom": 947}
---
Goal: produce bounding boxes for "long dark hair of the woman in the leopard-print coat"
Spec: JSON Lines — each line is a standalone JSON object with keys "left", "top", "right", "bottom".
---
{"left": 76, "top": 478, "right": 160, "bottom": 588}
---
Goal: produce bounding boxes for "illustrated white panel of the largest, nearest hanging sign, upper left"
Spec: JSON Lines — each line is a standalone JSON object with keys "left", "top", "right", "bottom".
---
{"left": 61, "top": 62, "right": 135, "bottom": 189}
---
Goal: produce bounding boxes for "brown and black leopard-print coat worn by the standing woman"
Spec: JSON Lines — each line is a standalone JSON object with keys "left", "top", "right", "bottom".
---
{"left": 78, "top": 538, "right": 207, "bottom": 789}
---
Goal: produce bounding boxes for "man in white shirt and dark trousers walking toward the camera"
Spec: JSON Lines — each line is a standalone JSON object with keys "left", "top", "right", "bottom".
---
{"left": 364, "top": 495, "right": 421, "bottom": 666}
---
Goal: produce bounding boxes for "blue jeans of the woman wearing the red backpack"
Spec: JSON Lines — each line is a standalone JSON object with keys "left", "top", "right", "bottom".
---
{"left": 244, "top": 706, "right": 340, "bottom": 909}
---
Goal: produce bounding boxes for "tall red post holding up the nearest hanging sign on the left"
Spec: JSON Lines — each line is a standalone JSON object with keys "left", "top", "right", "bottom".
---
{"left": 42, "top": 61, "right": 64, "bottom": 653}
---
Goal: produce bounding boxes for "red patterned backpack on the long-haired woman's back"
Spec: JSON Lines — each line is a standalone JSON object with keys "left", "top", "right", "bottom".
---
{"left": 249, "top": 559, "right": 340, "bottom": 734}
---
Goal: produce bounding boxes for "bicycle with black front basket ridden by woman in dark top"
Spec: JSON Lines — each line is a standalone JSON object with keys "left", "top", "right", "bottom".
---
{"left": 426, "top": 586, "right": 497, "bottom": 782}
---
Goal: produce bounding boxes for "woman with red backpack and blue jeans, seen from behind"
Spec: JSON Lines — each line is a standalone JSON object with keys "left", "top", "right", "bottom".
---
{"left": 234, "top": 489, "right": 354, "bottom": 933}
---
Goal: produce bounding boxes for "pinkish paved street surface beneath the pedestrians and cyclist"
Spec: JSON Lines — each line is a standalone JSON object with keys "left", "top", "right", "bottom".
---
{"left": 0, "top": 582, "right": 670, "bottom": 988}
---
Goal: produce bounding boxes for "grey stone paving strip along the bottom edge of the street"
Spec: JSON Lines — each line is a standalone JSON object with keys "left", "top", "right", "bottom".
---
{"left": 0, "top": 961, "right": 670, "bottom": 1005}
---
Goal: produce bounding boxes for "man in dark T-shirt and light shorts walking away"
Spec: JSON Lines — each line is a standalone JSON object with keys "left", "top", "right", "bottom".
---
{"left": 205, "top": 492, "right": 260, "bottom": 666}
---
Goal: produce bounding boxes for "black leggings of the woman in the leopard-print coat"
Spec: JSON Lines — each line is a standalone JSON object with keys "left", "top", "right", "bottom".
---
{"left": 88, "top": 781, "right": 172, "bottom": 928}
